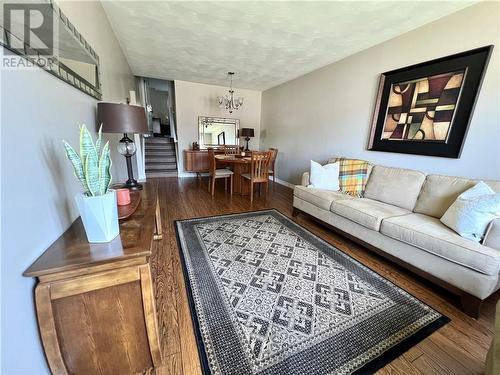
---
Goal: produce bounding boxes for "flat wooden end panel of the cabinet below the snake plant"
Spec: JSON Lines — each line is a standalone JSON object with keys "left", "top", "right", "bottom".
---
{"left": 36, "top": 264, "right": 161, "bottom": 374}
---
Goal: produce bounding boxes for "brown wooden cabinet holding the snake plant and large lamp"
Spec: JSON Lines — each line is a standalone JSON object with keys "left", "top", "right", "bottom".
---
{"left": 24, "top": 183, "right": 161, "bottom": 374}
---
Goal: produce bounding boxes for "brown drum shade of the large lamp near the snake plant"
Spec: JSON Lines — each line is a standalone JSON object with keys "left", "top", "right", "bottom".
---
{"left": 97, "top": 102, "right": 149, "bottom": 133}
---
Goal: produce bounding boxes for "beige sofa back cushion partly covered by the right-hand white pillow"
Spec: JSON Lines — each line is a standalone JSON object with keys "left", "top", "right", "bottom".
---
{"left": 413, "top": 175, "right": 476, "bottom": 219}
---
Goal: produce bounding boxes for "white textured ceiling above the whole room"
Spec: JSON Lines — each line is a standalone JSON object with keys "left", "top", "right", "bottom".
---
{"left": 103, "top": 1, "right": 471, "bottom": 90}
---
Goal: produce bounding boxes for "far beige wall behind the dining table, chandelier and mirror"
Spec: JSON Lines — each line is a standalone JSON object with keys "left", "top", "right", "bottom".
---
{"left": 175, "top": 81, "right": 261, "bottom": 176}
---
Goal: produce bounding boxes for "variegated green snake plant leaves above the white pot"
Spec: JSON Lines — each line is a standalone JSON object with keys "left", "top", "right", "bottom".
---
{"left": 63, "top": 125, "right": 112, "bottom": 197}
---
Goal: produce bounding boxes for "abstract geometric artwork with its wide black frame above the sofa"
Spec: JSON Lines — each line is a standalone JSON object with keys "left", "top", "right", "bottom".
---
{"left": 368, "top": 46, "right": 493, "bottom": 158}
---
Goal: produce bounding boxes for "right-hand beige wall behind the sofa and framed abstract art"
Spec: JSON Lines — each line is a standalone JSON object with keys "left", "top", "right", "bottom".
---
{"left": 260, "top": 2, "right": 500, "bottom": 183}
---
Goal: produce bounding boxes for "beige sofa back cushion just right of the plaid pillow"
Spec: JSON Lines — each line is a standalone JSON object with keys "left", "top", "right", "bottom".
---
{"left": 365, "top": 165, "right": 425, "bottom": 211}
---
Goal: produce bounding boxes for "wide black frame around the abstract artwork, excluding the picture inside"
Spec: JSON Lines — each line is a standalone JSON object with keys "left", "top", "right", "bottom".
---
{"left": 368, "top": 45, "right": 493, "bottom": 158}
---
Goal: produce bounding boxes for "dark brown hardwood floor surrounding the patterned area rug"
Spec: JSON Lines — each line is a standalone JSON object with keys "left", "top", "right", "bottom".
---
{"left": 144, "top": 178, "right": 500, "bottom": 375}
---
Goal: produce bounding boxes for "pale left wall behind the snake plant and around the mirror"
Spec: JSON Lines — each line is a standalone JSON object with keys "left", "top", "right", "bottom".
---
{"left": 0, "top": 2, "right": 135, "bottom": 375}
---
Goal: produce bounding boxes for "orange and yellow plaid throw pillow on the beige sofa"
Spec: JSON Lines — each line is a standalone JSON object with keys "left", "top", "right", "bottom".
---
{"left": 336, "top": 158, "right": 369, "bottom": 197}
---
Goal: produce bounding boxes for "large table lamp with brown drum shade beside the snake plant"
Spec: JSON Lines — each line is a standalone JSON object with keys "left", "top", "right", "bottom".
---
{"left": 97, "top": 102, "right": 149, "bottom": 190}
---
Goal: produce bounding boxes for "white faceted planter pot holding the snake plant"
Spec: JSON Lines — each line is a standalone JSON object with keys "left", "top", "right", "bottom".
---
{"left": 75, "top": 190, "right": 120, "bottom": 242}
